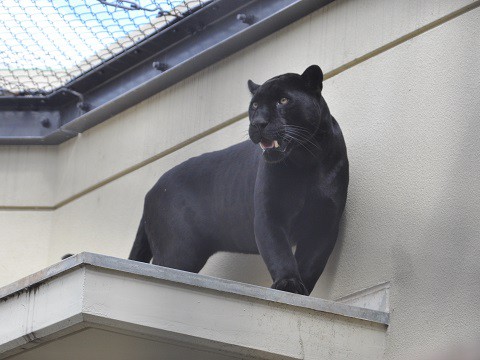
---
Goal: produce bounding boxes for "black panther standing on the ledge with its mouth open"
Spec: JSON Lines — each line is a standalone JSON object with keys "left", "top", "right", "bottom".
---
{"left": 129, "top": 65, "right": 349, "bottom": 295}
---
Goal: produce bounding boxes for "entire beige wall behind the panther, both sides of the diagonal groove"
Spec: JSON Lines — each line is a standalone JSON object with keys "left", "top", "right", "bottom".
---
{"left": 0, "top": 0, "right": 480, "bottom": 359}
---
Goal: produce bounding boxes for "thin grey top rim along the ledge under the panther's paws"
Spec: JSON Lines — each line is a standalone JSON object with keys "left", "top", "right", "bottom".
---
{"left": 0, "top": 252, "right": 389, "bottom": 325}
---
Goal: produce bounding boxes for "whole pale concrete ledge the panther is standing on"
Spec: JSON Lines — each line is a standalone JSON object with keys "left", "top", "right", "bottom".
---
{"left": 0, "top": 253, "right": 388, "bottom": 360}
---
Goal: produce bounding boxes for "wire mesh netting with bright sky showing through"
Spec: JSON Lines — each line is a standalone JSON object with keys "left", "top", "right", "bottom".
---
{"left": 0, "top": 0, "right": 211, "bottom": 96}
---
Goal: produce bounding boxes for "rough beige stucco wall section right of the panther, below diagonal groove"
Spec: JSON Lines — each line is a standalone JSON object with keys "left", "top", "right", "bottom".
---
{"left": 317, "top": 9, "right": 480, "bottom": 358}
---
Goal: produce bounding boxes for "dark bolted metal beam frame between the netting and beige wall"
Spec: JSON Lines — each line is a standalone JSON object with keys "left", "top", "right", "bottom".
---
{"left": 0, "top": 0, "right": 333, "bottom": 145}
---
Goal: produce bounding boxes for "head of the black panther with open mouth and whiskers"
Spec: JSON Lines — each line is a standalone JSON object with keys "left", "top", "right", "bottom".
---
{"left": 248, "top": 65, "right": 323, "bottom": 163}
